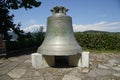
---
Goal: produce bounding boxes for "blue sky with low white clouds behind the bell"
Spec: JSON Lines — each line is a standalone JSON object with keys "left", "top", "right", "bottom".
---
{"left": 10, "top": 0, "right": 120, "bottom": 32}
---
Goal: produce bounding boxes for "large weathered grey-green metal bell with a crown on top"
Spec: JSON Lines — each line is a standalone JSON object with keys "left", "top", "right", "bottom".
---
{"left": 38, "top": 6, "right": 82, "bottom": 56}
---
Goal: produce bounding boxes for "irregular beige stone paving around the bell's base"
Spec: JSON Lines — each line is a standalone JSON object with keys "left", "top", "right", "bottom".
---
{"left": 0, "top": 53, "right": 120, "bottom": 80}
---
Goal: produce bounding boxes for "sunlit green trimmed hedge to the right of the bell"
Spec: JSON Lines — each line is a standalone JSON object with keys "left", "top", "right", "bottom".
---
{"left": 75, "top": 32, "right": 120, "bottom": 51}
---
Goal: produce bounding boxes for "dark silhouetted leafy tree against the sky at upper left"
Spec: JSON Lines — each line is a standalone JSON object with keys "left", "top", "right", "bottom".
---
{"left": 0, "top": 0, "right": 41, "bottom": 40}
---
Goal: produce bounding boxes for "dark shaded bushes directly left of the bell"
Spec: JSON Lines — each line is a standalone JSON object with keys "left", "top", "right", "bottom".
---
{"left": 6, "top": 26, "right": 44, "bottom": 51}
